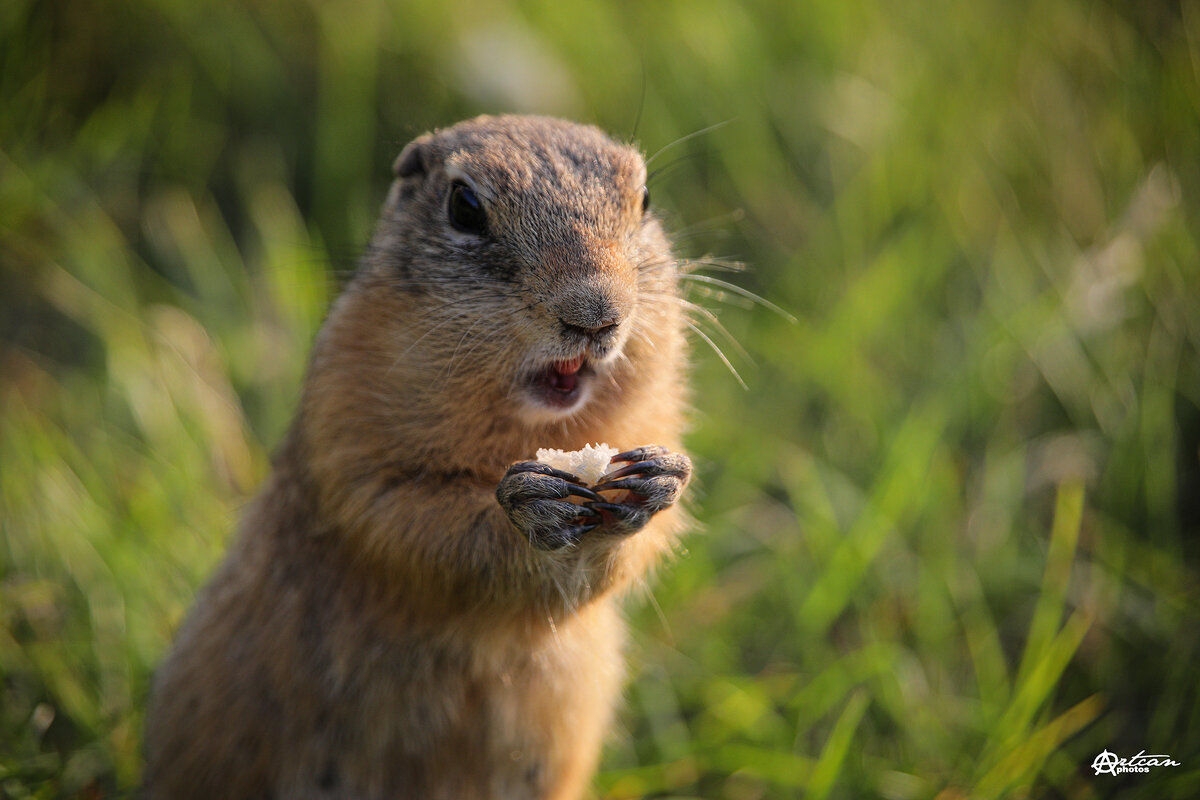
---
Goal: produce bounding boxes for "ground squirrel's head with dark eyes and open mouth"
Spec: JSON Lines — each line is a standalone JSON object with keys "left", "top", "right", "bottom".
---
{"left": 304, "top": 115, "right": 683, "bottom": 474}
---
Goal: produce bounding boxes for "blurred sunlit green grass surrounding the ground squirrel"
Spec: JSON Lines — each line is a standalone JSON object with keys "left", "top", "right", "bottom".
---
{"left": 0, "top": 0, "right": 1200, "bottom": 800}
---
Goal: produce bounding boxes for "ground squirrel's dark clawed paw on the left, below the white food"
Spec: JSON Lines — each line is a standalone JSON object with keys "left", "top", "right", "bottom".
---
{"left": 496, "top": 461, "right": 604, "bottom": 551}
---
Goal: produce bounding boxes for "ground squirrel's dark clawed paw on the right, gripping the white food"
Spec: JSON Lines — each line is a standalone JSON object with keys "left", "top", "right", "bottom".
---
{"left": 584, "top": 445, "right": 691, "bottom": 534}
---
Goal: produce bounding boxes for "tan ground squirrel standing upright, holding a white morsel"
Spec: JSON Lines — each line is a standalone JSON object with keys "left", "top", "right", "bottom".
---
{"left": 145, "top": 116, "right": 691, "bottom": 800}
